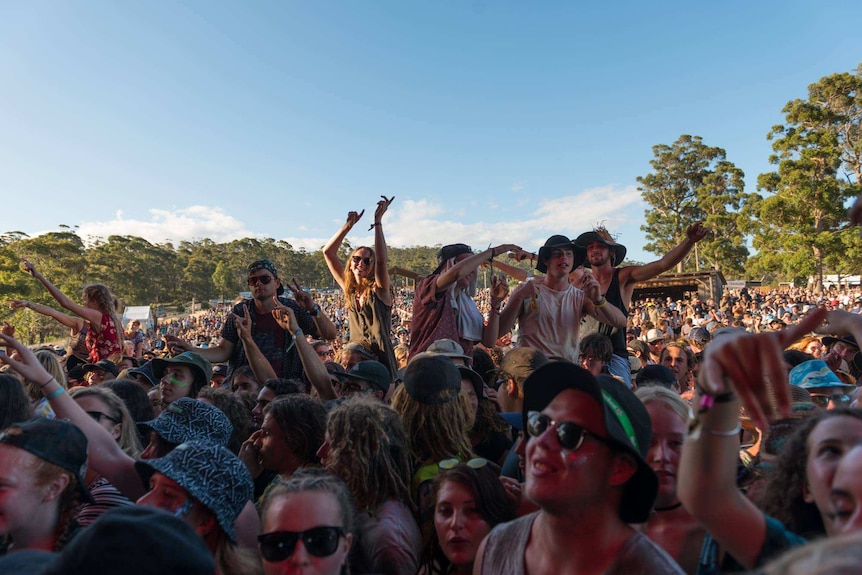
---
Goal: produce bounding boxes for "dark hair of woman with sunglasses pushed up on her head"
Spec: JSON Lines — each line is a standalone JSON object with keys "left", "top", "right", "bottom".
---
{"left": 422, "top": 461, "right": 515, "bottom": 574}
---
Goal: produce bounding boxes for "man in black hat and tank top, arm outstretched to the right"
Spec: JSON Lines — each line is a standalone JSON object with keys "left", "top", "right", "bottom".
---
{"left": 575, "top": 222, "right": 707, "bottom": 387}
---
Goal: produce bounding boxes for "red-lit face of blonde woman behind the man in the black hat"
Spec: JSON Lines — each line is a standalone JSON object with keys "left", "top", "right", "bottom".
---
{"left": 646, "top": 401, "right": 687, "bottom": 508}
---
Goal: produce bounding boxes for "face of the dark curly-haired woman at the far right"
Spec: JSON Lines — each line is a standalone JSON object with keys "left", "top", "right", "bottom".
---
{"left": 804, "top": 416, "right": 862, "bottom": 535}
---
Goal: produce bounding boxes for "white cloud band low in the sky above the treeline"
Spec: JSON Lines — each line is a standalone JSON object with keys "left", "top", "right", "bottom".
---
{"left": 47, "top": 185, "right": 643, "bottom": 255}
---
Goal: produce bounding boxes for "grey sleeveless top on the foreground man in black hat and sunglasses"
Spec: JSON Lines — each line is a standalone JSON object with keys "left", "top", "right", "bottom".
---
{"left": 481, "top": 512, "right": 685, "bottom": 575}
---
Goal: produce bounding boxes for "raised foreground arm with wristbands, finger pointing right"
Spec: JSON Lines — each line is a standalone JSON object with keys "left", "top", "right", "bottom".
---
{"left": 677, "top": 311, "right": 823, "bottom": 569}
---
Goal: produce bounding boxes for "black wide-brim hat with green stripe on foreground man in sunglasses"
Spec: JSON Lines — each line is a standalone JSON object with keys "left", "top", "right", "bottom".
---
{"left": 522, "top": 361, "right": 658, "bottom": 523}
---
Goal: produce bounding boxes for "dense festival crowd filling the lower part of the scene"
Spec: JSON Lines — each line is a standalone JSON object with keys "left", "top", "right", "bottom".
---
{"left": 0, "top": 197, "right": 862, "bottom": 575}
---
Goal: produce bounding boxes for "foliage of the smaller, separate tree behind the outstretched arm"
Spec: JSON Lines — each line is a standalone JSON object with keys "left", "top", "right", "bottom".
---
{"left": 637, "top": 135, "right": 748, "bottom": 275}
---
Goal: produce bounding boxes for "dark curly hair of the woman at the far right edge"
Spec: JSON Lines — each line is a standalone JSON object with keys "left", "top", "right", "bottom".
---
{"left": 763, "top": 407, "right": 862, "bottom": 538}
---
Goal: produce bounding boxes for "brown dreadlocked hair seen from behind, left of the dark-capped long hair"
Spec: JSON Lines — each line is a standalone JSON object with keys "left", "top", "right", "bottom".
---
{"left": 325, "top": 394, "right": 411, "bottom": 516}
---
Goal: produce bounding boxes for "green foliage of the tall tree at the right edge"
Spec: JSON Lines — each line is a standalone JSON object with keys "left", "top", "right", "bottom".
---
{"left": 749, "top": 62, "right": 862, "bottom": 290}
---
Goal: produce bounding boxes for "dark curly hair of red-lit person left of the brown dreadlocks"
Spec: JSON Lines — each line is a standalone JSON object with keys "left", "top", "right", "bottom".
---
{"left": 263, "top": 393, "right": 326, "bottom": 465}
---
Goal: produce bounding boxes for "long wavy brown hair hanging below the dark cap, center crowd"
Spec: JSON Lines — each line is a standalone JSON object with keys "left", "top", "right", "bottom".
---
{"left": 392, "top": 385, "right": 473, "bottom": 464}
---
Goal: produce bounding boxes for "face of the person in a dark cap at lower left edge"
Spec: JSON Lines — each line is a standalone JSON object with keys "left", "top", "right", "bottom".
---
{"left": 0, "top": 444, "right": 57, "bottom": 537}
